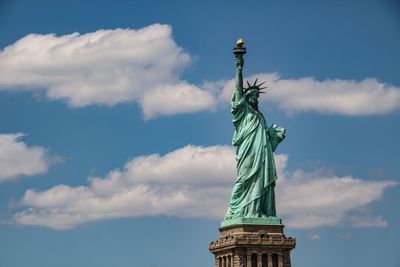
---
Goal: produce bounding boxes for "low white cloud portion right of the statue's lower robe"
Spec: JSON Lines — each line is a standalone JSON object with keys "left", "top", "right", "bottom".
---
{"left": 277, "top": 170, "right": 397, "bottom": 228}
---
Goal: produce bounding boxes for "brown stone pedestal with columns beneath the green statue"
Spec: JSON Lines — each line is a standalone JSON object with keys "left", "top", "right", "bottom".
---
{"left": 209, "top": 224, "right": 296, "bottom": 267}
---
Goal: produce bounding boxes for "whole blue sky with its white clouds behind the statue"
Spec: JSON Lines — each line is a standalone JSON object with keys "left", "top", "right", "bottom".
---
{"left": 0, "top": 0, "right": 400, "bottom": 267}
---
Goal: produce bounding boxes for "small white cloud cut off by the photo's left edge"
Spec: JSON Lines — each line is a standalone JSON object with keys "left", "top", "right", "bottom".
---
{"left": 0, "top": 133, "right": 50, "bottom": 183}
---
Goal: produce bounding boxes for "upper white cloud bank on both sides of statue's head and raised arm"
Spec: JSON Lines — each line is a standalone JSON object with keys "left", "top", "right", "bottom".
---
{"left": 0, "top": 24, "right": 400, "bottom": 119}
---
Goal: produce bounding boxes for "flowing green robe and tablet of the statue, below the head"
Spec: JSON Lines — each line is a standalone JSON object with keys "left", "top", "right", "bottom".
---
{"left": 225, "top": 94, "right": 285, "bottom": 220}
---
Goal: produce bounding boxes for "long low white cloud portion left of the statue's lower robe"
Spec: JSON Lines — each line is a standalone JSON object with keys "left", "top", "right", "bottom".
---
{"left": 15, "top": 146, "right": 235, "bottom": 229}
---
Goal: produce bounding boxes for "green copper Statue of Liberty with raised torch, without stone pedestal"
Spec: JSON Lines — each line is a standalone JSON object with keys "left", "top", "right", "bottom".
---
{"left": 222, "top": 39, "right": 285, "bottom": 226}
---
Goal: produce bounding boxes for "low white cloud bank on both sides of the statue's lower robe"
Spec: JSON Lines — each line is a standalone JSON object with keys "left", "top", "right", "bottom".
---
{"left": 14, "top": 145, "right": 396, "bottom": 229}
